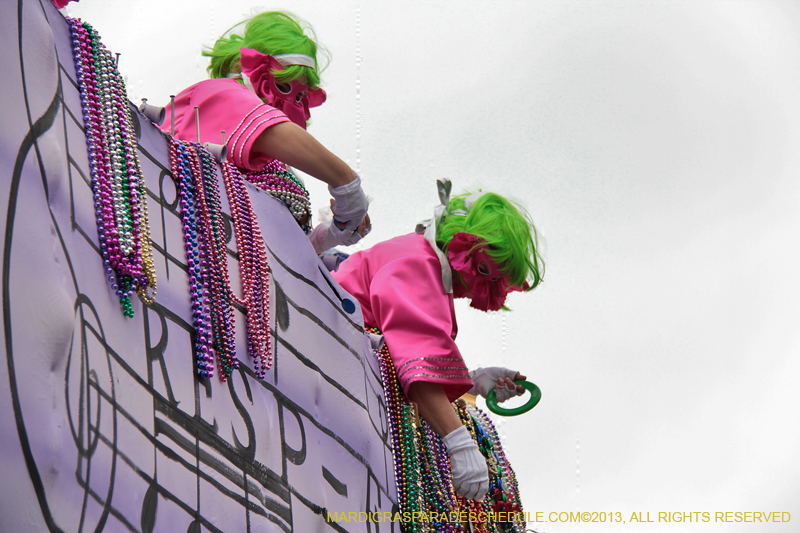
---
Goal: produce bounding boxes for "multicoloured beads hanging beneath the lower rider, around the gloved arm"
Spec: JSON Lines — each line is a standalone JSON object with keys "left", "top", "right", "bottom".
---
{"left": 370, "top": 328, "right": 525, "bottom": 533}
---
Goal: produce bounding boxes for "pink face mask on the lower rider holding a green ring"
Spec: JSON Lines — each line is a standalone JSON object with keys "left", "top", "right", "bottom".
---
{"left": 447, "top": 233, "right": 528, "bottom": 311}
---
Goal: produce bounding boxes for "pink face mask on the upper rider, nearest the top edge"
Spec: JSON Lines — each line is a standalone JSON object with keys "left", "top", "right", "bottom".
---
{"left": 241, "top": 48, "right": 327, "bottom": 129}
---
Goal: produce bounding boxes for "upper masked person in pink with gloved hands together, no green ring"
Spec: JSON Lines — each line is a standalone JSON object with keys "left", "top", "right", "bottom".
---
{"left": 161, "top": 11, "right": 370, "bottom": 252}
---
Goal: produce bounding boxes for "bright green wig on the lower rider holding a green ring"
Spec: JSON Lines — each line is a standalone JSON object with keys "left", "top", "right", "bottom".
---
{"left": 436, "top": 192, "right": 544, "bottom": 290}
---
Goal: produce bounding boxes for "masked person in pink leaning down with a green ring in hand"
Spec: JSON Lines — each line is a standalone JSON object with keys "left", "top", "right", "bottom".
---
{"left": 333, "top": 181, "right": 544, "bottom": 499}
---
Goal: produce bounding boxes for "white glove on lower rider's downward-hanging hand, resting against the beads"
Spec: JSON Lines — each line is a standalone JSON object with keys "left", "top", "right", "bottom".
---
{"left": 442, "top": 426, "right": 489, "bottom": 500}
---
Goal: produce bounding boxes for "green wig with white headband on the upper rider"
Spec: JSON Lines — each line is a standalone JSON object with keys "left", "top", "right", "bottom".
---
{"left": 203, "top": 11, "right": 327, "bottom": 89}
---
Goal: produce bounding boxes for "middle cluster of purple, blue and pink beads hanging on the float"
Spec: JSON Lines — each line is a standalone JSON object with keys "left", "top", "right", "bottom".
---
{"left": 170, "top": 140, "right": 272, "bottom": 382}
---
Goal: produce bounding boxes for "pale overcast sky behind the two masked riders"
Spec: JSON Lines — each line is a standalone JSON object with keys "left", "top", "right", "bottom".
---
{"left": 67, "top": 0, "right": 800, "bottom": 532}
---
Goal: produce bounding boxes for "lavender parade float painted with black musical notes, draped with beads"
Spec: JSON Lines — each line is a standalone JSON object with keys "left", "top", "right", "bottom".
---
{"left": 0, "top": 0, "right": 524, "bottom": 533}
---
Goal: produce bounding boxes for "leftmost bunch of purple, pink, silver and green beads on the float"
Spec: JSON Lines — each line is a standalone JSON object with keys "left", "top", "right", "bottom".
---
{"left": 67, "top": 17, "right": 156, "bottom": 317}
